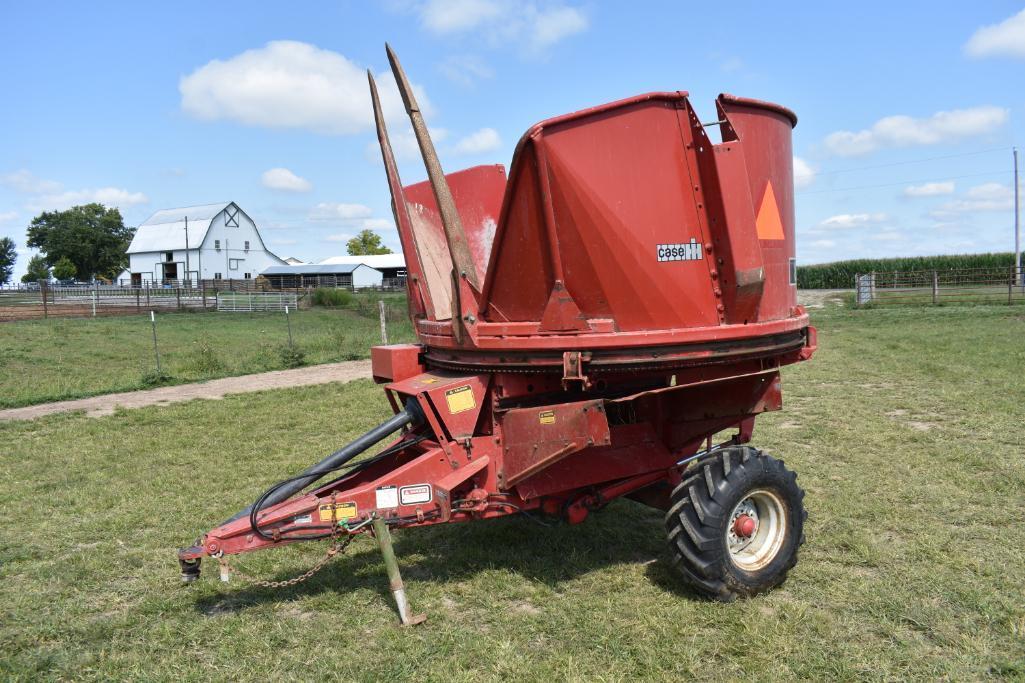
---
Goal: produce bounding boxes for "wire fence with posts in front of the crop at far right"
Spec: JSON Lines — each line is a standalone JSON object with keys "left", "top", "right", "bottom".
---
{"left": 855, "top": 267, "right": 1025, "bottom": 306}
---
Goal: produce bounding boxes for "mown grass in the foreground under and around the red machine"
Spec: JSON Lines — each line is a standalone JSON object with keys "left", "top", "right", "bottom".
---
{"left": 0, "top": 307, "right": 1025, "bottom": 682}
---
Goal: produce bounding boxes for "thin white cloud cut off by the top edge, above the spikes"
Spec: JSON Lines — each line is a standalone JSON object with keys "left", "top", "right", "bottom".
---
{"left": 418, "top": 0, "right": 589, "bottom": 52}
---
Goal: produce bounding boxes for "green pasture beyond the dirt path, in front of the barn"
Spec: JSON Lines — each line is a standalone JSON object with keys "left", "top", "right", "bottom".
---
{"left": 0, "top": 297, "right": 412, "bottom": 408}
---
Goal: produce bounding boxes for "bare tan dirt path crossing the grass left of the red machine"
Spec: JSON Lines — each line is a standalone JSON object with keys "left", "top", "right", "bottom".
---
{"left": 0, "top": 360, "right": 371, "bottom": 420}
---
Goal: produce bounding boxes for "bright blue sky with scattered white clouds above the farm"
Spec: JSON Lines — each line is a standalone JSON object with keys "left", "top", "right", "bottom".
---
{"left": 0, "top": 0, "right": 1025, "bottom": 275}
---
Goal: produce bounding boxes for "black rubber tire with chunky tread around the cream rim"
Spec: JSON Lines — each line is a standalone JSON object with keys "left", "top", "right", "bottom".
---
{"left": 665, "top": 446, "right": 808, "bottom": 602}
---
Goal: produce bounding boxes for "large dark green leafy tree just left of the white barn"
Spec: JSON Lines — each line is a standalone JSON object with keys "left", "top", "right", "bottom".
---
{"left": 28, "top": 203, "right": 135, "bottom": 279}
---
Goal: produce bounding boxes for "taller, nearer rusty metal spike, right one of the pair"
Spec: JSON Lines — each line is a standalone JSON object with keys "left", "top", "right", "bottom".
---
{"left": 384, "top": 43, "right": 481, "bottom": 291}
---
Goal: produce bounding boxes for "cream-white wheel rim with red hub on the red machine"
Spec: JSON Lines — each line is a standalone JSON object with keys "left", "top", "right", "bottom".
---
{"left": 726, "top": 488, "right": 787, "bottom": 571}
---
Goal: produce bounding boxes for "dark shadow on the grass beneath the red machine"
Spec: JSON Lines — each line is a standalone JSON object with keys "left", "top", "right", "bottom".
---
{"left": 188, "top": 500, "right": 704, "bottom": 615}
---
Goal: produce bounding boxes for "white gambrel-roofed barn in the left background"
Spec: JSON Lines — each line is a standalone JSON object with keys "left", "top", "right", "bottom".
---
{"left": 128, "top": 202, "right": 285, "bottom": 287}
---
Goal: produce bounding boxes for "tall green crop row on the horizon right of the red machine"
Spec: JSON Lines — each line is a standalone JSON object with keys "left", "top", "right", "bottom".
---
{"left": 797, "top": 251, "right": 1014, "bottom": 289}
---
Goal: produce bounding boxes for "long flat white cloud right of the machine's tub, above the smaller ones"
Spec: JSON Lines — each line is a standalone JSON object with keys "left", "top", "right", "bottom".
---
{"left": 825, "top": 106, "right": 1009, "bottom": 157}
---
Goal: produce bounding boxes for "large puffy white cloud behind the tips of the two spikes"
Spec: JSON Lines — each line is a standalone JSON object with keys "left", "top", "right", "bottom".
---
{"left": 178, "top": 40, "right": 434, "bottom": 134}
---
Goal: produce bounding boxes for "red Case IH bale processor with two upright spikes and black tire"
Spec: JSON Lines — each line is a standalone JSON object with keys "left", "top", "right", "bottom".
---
{"left": 178, "top": 49, "right": 816, "bottom": 624}
